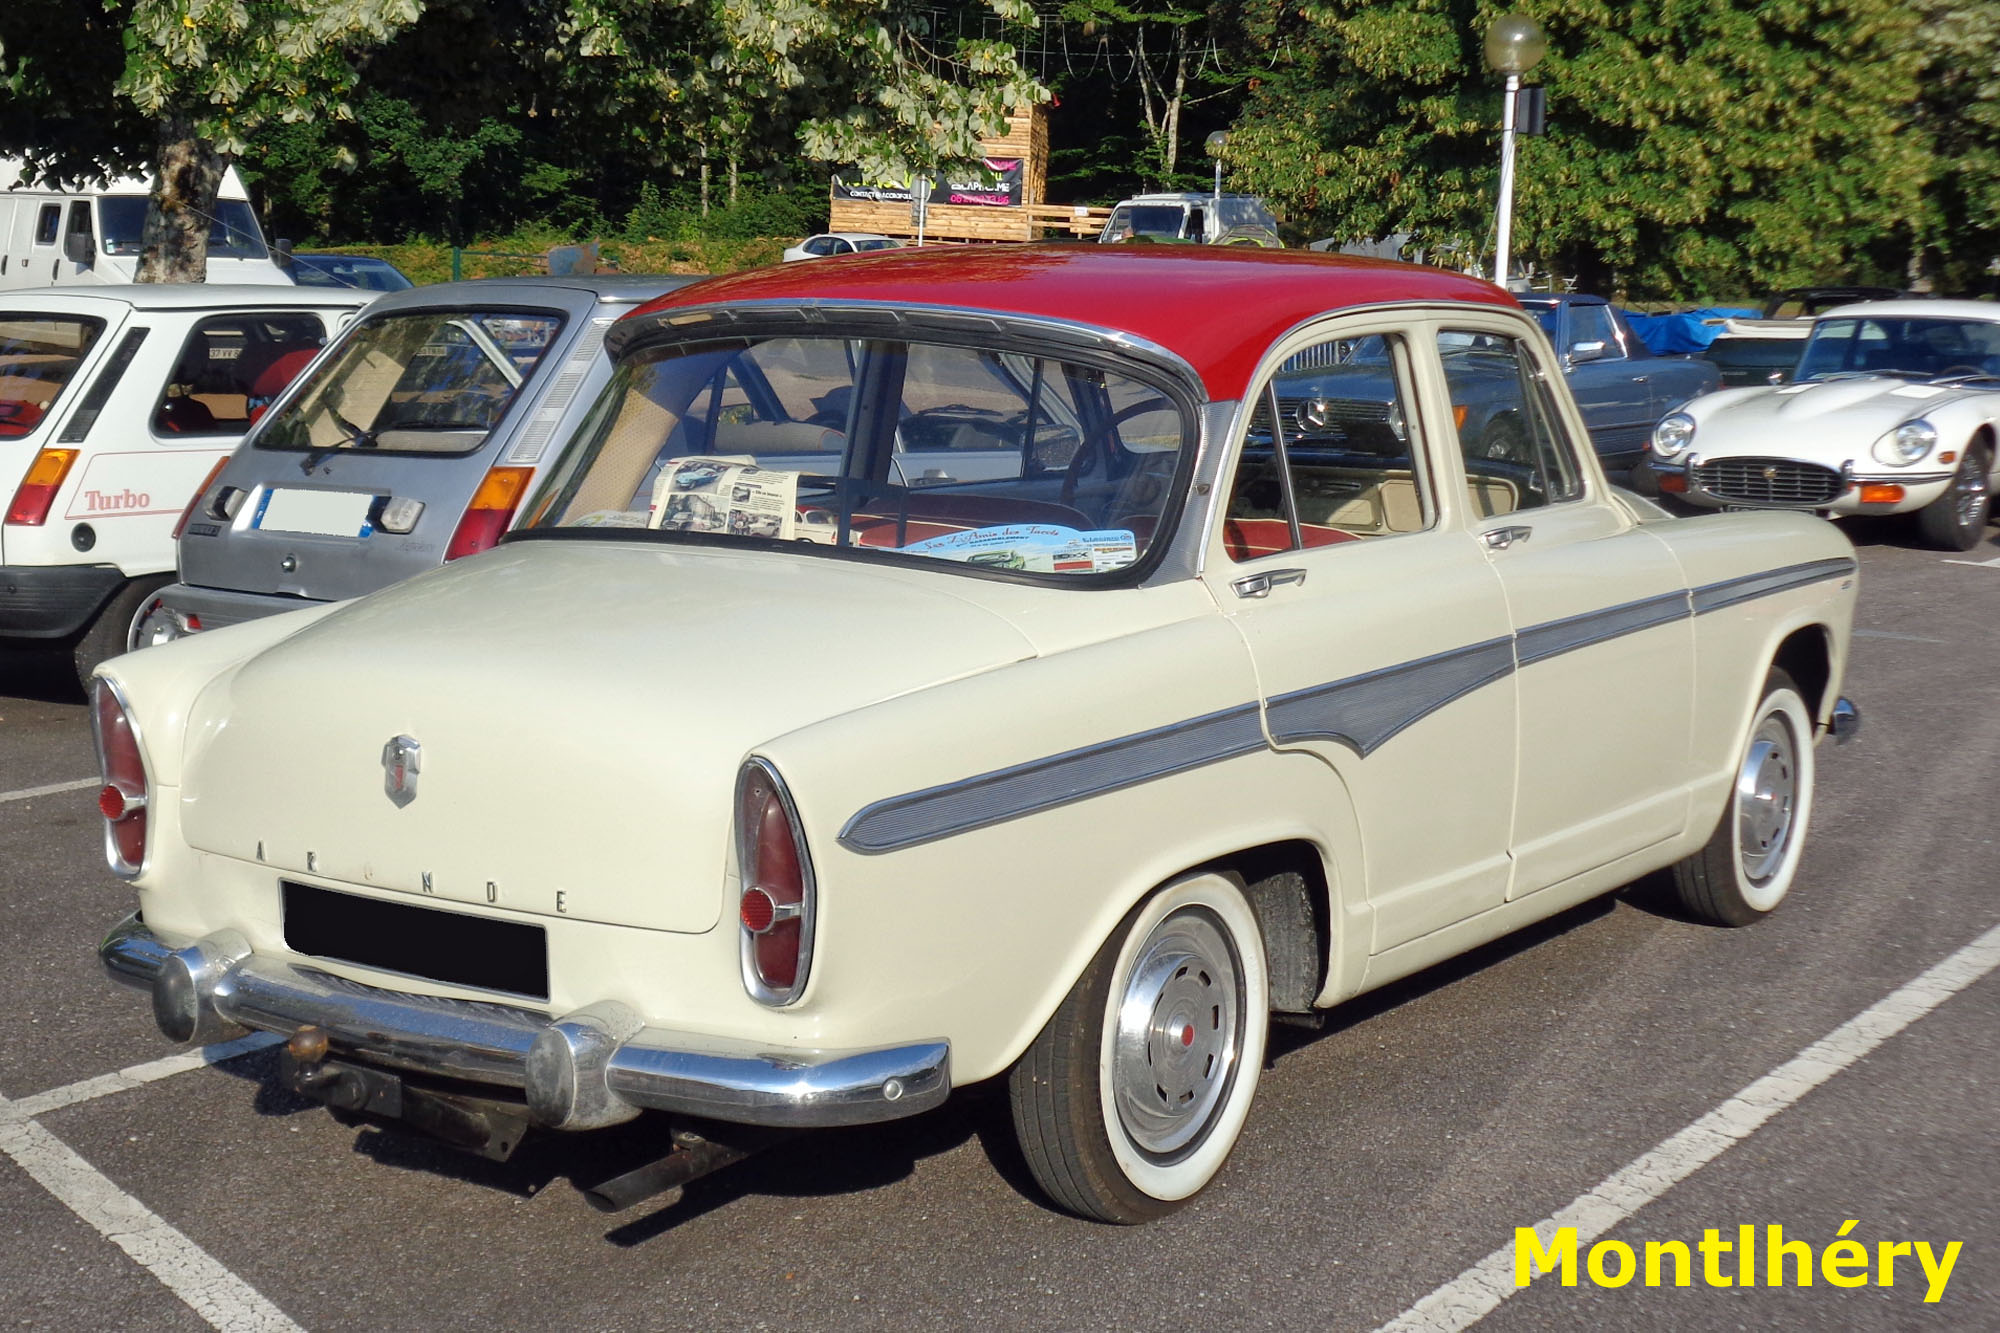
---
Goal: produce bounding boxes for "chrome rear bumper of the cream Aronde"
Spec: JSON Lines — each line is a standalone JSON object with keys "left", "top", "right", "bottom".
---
{"left": 98, "top": 913, "right": 952, "bottom": 1129}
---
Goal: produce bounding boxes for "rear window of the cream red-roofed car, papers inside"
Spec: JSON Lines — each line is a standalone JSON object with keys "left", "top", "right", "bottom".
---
{"left": 528, "top": 336, "right": 1190, "bottom": 576}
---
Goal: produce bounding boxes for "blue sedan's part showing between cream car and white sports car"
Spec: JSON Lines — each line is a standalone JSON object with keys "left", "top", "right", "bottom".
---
{"left": 1520, "top": 294, "right": 1722, "bottom": 464}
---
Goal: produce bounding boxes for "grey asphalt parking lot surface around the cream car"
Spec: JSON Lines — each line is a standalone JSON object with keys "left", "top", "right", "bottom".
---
{"left": 0, "top": 526, "right": 2000, "bottom": 1331}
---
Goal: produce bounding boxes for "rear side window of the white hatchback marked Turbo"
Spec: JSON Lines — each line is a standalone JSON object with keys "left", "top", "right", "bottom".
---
{"left": 152, "top": 312, "right": 326, "bottom": 436}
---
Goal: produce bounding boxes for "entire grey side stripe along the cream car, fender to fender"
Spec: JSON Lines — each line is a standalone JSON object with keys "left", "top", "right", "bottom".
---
{"left": 840, "top": 558, "right": 1856, "bottom": 855}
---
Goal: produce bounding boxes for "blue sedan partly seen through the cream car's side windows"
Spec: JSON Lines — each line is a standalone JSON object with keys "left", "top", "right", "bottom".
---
{"left": 1258, "top": 296, "right": 1720, "bottom": 478}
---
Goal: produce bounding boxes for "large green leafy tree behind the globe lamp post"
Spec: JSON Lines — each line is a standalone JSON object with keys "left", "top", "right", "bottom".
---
{"left": 1228, "top": 0, "right": 1930, "bottom": 294}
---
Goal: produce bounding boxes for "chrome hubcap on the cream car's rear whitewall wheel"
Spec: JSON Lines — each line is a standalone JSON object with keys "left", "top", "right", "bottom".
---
{"left": 1112, "top": 911, "right": 1242, "bottom": 1155}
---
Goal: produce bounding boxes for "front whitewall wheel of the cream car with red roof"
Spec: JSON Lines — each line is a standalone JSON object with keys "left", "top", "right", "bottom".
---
{"left": 1674, "top": 669, "right": 1812, "bottom": 927}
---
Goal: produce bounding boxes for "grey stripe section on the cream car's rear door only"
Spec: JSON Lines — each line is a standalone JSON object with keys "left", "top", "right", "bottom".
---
{"left": 1270, "top": 638, "right": 1514, "bottom": 759}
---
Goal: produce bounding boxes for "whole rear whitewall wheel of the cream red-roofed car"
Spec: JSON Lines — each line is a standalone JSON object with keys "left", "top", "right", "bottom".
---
{"left": 1008, "top": 875, "right": 1270, "bottom": 1223}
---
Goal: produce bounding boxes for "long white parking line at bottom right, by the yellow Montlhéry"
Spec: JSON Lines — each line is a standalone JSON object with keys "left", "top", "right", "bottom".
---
{"left": 1376, "top": 912, "right": 2000, "bottom": 1333}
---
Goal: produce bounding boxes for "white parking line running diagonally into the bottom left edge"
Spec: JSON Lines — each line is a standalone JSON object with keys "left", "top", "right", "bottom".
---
{"left": 0, "top": 1097, "right": 298, "bottom": 1331}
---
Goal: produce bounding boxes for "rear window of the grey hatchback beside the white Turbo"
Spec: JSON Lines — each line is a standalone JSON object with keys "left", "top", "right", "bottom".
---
{"left": 258, "top": 308, "right": 562, "bottom": 454}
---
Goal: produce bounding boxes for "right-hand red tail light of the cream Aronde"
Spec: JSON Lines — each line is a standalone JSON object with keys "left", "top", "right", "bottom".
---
{"left": 736, "top": 759, "right": 814, "bottom": 1005}
